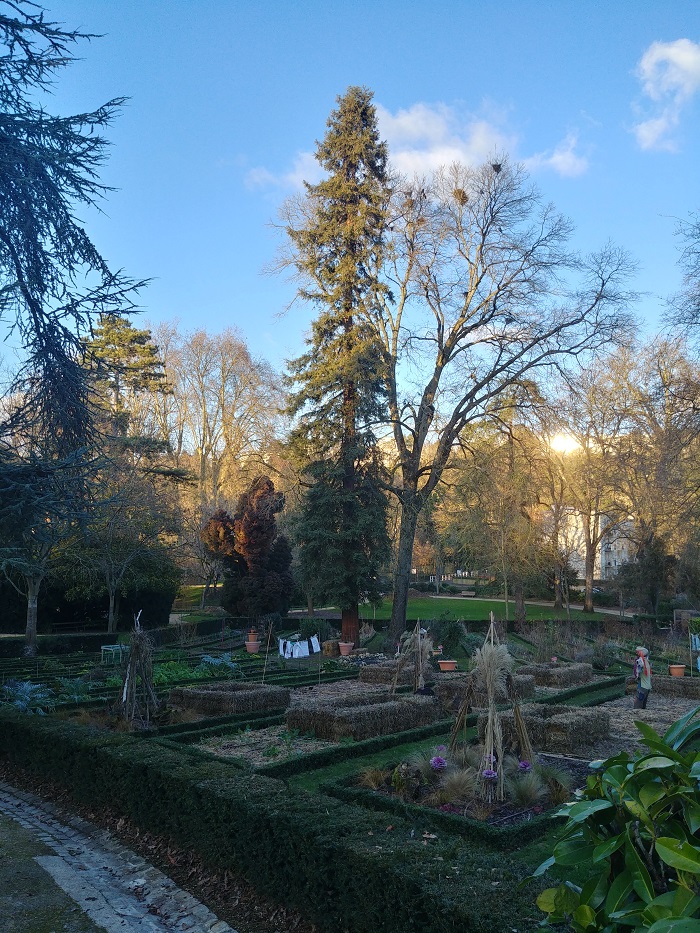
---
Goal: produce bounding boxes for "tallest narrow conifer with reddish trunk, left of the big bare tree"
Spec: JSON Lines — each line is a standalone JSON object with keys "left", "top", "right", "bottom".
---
{"left": 287, "top": 87, "right": 390, "bottom": 642}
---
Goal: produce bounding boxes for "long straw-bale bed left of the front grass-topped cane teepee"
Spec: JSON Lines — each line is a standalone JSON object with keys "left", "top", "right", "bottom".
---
{"left": 287, "top": 696, "right": 440, "bottom": 742}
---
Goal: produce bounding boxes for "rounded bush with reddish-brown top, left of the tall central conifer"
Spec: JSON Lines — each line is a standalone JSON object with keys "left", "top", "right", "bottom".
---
{"left": 201, "top": 476, "right": 292, "bottom": 618}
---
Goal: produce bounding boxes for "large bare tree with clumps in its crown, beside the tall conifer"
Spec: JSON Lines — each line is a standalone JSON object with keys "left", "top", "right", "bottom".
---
{"left": 371, "top": 157, "right": 633, "bottom": 632}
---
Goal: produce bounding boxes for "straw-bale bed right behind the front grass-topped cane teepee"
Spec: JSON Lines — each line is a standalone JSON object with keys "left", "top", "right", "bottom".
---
{"left": 478, "top": 704, "right": 610, "bottom": 752}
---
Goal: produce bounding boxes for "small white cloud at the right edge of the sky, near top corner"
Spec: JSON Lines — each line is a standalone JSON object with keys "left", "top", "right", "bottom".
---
{"left": 634, "top": 39, "right": 700, "bottom": 150}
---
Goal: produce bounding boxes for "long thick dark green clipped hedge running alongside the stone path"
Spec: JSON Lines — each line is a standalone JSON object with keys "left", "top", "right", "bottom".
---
{"left": 0, "top": 712, "right": 540, "bottom": 933}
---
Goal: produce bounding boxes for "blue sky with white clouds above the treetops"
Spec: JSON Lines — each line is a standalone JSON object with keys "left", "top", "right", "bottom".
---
{"left": 37, "top": 0, "right": 700, "bottom": 367}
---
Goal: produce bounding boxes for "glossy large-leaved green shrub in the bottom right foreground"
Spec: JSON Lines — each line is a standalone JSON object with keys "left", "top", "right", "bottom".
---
{"left": 533, "top": 707, "right": 700, "bottom": 933}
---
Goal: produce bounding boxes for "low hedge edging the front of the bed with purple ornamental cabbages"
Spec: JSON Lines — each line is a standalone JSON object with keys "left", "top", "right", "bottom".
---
{"left": 319, "top": 775, "right": 558, "bottom": 852}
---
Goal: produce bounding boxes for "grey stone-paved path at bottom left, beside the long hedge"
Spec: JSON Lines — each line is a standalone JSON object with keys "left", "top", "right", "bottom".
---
{"left": 0, "top": 781, "right": 235, "bottom": 933}
